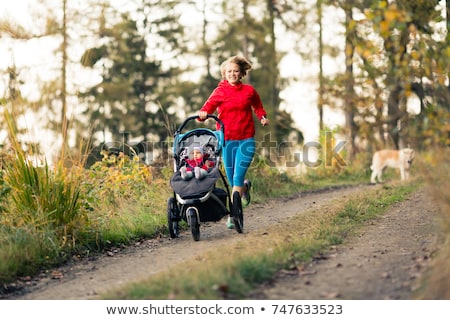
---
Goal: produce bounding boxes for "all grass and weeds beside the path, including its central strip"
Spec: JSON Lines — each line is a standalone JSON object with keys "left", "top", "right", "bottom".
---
{"left": 0, "top": 146, "right": 450, "bottom": 299}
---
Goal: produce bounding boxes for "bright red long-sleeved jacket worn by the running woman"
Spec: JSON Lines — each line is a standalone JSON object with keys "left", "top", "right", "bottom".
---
{"left": 201, "top": 80, "right": 267, "bottom": 140}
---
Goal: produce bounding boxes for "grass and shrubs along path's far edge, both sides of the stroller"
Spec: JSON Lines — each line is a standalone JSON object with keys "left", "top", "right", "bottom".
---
{"left": 0, "top": 148, "right": 367, "bottom": 287}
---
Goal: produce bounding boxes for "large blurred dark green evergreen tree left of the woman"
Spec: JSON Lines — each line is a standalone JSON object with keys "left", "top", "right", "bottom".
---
{"left": 80, "top": 2, "right": 183, "bottom": 148}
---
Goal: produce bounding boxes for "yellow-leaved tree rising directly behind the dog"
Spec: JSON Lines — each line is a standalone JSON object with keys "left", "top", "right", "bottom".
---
{"left": 368, "top": 0, "right": 448, "bottom": 148}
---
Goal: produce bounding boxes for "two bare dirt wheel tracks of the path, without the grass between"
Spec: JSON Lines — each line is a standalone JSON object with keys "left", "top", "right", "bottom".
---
{"left": 7, "top": 185, "right": 435, "bottom": 300}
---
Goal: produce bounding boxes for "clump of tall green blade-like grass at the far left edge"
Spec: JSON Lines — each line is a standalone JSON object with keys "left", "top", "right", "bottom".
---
{"left": 3, "top": 153, "right": 82, "bottom": 238}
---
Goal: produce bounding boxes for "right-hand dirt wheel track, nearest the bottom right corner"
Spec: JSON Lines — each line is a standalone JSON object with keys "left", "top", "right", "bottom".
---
{"left": 248, "top": 186, "right": 437, "bottom": 300}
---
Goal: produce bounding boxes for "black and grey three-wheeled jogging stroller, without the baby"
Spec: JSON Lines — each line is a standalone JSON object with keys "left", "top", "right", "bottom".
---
{"left": 167, "top": 115, "right": 244, "bottom": 241}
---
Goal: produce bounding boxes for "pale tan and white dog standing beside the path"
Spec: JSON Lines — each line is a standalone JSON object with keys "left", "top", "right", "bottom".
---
{"left": 370, "top": 148, "right": 415, "bottom": 183}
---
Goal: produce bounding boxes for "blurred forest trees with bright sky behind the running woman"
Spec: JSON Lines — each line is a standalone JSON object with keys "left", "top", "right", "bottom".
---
{"left": 0, "top": 0, "right": 450, "bottom": 165}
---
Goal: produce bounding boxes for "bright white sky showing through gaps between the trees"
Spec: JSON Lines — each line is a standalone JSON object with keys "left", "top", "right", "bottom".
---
{"left": 0, "top": 0, "right": 344, "bottom": 159}
